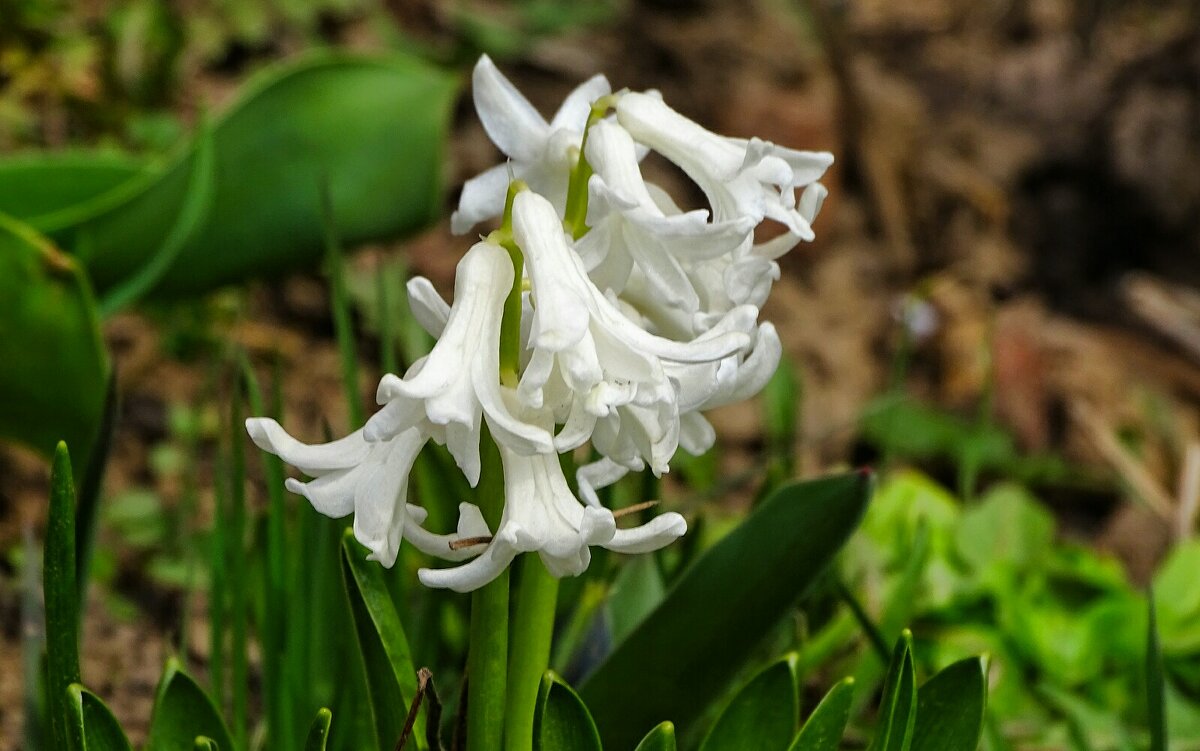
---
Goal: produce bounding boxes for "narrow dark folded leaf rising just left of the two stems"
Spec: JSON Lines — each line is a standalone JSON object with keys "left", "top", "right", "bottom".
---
{"left": 342, "top": 528, "right": 426, "bottom": 750}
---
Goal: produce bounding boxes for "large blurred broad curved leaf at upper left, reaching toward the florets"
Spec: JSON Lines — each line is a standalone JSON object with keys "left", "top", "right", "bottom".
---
{"left": 10, "top": 53, "right": 457, "bottom": 296}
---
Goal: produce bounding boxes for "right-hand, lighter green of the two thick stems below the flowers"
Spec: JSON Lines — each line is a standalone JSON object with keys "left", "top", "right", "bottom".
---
{"left": 504, "top": 553, "right": 558, "bottom": 751}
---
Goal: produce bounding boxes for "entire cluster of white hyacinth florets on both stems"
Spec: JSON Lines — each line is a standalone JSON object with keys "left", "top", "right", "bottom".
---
{"left": 246, "top": 56, "right": 833, "bottom": 591}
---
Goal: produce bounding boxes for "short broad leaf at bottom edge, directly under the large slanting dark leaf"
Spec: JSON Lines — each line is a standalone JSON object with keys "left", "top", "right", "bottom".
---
{"left": 700, "top": 655, "right": 800, "bottom": 751}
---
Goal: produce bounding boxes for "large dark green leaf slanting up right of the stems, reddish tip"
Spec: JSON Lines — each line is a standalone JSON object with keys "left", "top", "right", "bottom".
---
{"left": 581, "top": 473, "right": 872, "bottom": 749}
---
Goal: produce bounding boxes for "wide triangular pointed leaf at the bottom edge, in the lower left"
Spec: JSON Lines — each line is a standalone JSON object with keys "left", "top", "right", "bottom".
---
{"left": 145, "top": 657, "right": 234, "bottom": 751}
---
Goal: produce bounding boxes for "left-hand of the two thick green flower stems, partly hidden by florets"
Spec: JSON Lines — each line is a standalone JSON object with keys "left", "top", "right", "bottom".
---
{"left": 467, "top": 428, "right": 509, "bottom": 751}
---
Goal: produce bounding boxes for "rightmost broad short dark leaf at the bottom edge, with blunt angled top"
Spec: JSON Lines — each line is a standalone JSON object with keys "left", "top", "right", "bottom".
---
{"left": 912, "top": 657, "right": 988, "bottom": 751}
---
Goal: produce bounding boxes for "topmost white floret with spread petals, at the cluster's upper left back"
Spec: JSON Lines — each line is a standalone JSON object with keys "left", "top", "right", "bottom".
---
{"left": 450, "top": 55, "right": 612, "bottom": 234}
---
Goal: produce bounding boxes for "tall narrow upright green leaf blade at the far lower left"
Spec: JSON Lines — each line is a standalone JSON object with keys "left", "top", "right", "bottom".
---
{"left": 42, "top": 441, "right": 79, "bottom": 751}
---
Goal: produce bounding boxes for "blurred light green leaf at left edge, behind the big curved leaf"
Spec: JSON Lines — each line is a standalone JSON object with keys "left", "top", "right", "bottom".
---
{"left": 0, "top": 151, "right": 152, "bottom": 221}
